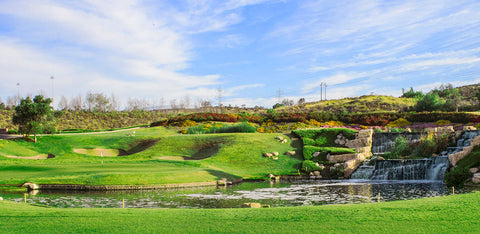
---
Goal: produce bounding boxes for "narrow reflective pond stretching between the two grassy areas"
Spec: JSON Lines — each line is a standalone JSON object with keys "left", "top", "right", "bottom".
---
{"left": 0, "top": 180, "right": 479, "bottom": 208}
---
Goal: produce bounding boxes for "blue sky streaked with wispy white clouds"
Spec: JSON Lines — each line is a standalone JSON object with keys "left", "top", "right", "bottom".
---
{"left": 0, "top": 0, "right": 480, "bottom": 107}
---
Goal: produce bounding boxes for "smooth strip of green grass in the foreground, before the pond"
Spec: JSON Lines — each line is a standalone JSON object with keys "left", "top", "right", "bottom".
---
{"left": 0, "top": 192, "right": 480, "bottom": 233}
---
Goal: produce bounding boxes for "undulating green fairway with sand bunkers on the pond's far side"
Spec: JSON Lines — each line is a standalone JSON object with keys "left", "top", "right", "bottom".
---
{"left": 0, "top": 127, "right": 301, "bottom": 185}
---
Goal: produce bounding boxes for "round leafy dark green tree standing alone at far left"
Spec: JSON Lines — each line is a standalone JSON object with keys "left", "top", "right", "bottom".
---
{"left": 12, "top": 95, "right": 54, "bottom": 143}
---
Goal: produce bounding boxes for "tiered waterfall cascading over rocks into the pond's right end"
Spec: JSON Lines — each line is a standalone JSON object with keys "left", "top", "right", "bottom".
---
{"left": 351, "top": 130, "right": 480, "bottom": 180}
